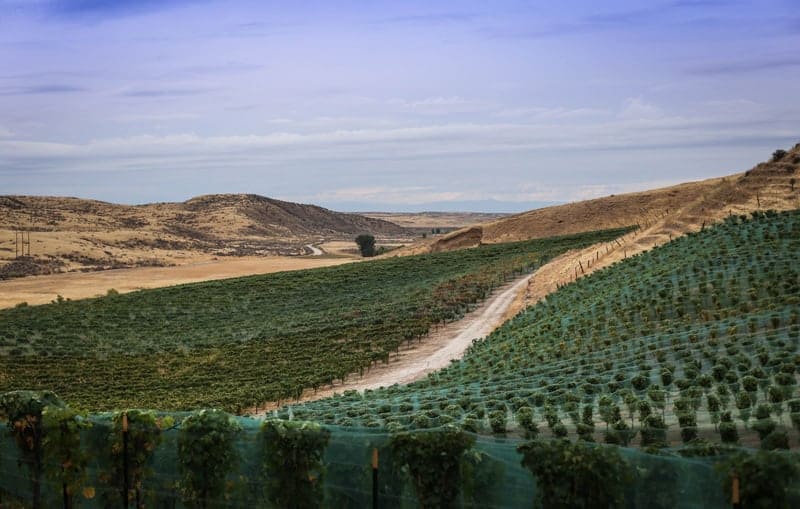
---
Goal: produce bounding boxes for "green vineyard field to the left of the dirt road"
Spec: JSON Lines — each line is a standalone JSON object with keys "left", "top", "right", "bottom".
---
{"left": 0, "top": 229, "right": 629, "bottom": 411}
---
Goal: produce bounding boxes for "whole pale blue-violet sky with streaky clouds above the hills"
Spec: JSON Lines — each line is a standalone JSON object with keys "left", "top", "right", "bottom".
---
{"left": 0, "top": 0, "right": 800, "bottom": 212}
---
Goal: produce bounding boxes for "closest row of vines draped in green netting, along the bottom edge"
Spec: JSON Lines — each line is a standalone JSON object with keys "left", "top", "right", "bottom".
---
{"left": 0, "top": 407, "right": 800, "bottom": 508}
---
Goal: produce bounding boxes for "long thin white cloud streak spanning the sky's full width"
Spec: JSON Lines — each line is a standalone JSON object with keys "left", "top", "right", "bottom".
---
{"left": 0, "top": 108, "right": 797, "bottom": 169}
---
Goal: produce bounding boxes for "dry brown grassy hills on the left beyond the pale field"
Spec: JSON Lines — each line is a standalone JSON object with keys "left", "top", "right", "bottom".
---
{"left": 0, "top": 195, "right": 413, "bottom": 279}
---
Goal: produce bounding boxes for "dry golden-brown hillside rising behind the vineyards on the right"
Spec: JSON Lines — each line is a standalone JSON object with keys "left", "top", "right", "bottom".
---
{"left": 400, "top": 144, "right": 800, "bottom": 255}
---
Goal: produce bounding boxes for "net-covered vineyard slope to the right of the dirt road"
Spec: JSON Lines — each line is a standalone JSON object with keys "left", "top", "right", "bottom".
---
{"left": 290, "top": 211, "right": 800, "bottom": 448}
